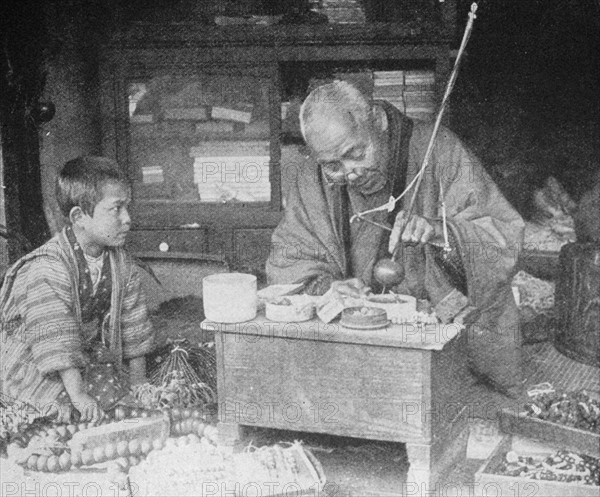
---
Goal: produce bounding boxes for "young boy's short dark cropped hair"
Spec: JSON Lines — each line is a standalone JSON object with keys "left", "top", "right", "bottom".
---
{"left": 56, "top": 155, "right": 131, "bottom": 217}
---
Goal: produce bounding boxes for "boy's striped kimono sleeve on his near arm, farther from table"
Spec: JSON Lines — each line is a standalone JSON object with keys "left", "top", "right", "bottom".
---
{"left": 23, "top": 258, "right": 87, "bottom": 374}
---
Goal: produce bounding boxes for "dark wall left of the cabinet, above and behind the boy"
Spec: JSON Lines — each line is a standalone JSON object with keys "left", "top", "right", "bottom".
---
{"left": 0, "top": 0, "right": 121, "bottom": 252}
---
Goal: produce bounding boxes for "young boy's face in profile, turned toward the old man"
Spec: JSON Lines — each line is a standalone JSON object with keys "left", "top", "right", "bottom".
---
{"left": 78, "top": 182, "right": 131, "bottom": 255}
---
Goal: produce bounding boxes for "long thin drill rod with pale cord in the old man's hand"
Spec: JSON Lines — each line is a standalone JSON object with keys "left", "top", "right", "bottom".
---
{"left": 350, "top": 3, "right": 477, "bottom": 240}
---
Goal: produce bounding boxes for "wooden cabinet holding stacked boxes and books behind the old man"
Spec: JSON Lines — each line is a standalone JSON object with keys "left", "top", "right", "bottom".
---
{"left": 101, "top": 23, "right": 450, "bottom": 268}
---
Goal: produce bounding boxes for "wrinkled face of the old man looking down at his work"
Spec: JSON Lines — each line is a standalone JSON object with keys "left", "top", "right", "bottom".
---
{"left": 307, "top": 108, "right": 387, "bottom": 195}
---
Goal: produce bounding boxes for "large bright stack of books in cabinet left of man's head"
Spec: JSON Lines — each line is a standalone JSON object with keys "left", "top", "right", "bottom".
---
{"left": 190, "top": 140, "right": 271, "bottom": 202}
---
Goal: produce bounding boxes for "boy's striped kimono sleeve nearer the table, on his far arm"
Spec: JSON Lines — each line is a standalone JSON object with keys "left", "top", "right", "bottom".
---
{"left": 121, "top": 267, "right": 154, "bottom": 359}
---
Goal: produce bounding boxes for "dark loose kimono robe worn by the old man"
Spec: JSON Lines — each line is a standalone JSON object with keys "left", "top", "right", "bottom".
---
{"left": 266, "top": 103, "right": 524, "bottom": 394}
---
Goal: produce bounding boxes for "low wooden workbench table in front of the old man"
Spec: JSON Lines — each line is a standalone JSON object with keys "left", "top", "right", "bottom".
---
{"left": 202, "top": 312, "right": 467, "bottom": 495}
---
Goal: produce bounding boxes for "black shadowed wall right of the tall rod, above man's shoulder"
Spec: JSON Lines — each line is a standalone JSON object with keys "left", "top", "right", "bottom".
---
{"left": 452, "top": 0, "right": 600, "bottom": 216}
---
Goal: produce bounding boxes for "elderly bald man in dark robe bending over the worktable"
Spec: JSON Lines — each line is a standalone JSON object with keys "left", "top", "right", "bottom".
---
{"left": 267, "top": 81, "right": 523, "bottom": 394}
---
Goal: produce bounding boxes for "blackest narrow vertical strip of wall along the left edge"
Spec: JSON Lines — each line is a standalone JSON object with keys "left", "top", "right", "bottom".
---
{"left": 0, "top": 1, "right": 48, "bottom": 259}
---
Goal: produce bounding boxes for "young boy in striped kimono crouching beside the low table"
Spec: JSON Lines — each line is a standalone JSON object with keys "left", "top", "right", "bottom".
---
{"left": 0, "top": 156, "right": 154, "bottom": 422}
